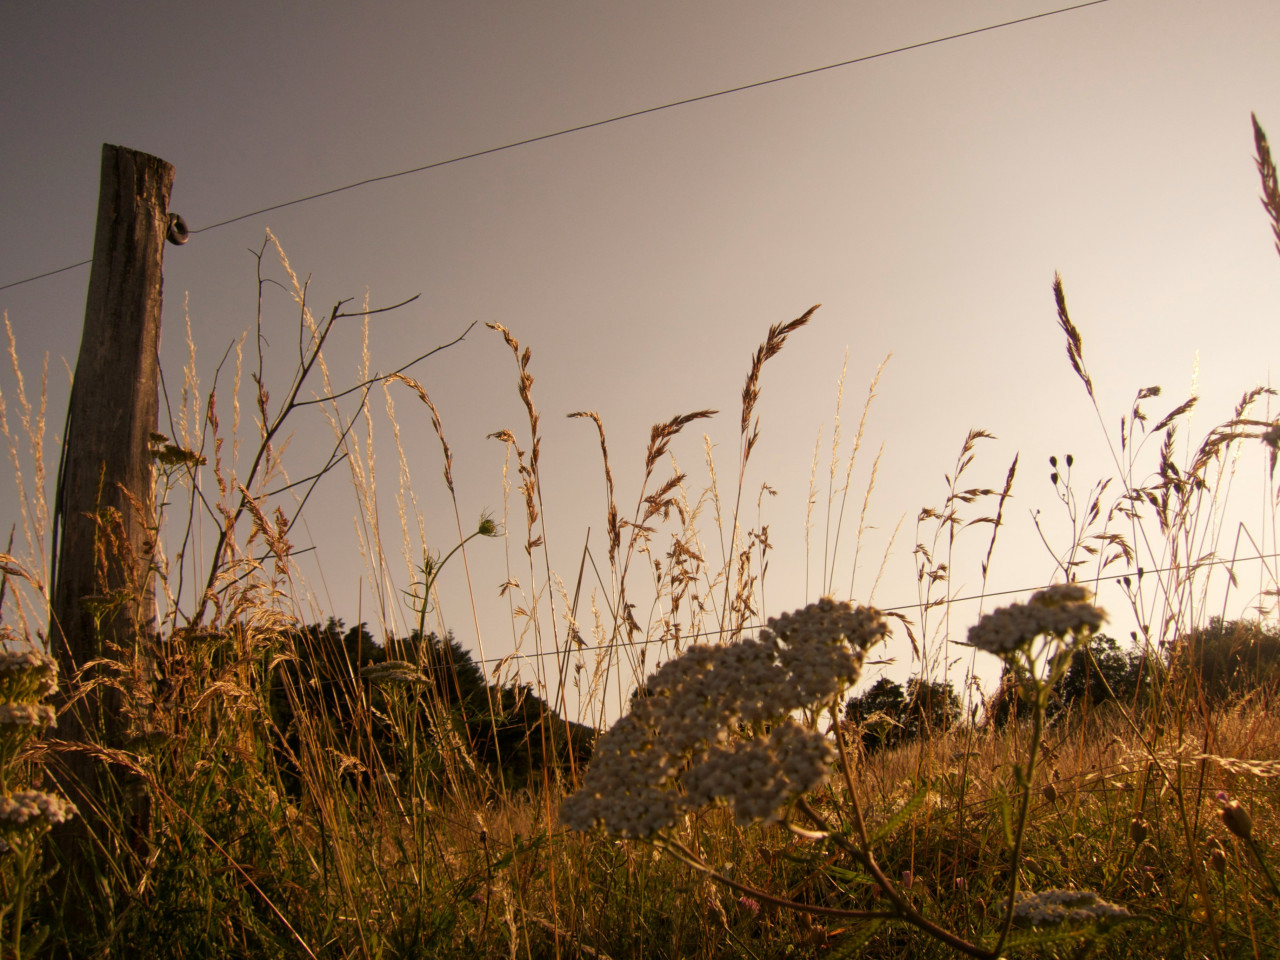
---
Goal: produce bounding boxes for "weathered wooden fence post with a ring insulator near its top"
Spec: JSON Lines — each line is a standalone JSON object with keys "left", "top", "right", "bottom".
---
{"left": 49, "top": 143, "right": 174, "bottom": 913}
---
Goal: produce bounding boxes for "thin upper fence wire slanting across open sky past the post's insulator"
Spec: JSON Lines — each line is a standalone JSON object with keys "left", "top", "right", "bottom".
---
{"left": 0, "top": 0, "right": 1110, "bottom": 291}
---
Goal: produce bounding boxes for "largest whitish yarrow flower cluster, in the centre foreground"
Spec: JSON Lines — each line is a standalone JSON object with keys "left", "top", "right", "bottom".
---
{"left": 561, "top": 598, "right": 887, "bottom": 837}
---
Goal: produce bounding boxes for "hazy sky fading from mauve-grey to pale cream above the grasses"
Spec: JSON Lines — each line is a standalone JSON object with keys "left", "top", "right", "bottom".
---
{"left": 0, "top": 0, "right": 1280, "bottom": 716}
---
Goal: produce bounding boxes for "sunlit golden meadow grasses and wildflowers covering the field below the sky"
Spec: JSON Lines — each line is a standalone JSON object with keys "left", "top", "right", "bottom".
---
{"left": 0, "top": 116, "right": 1280, "bottom": 960}
